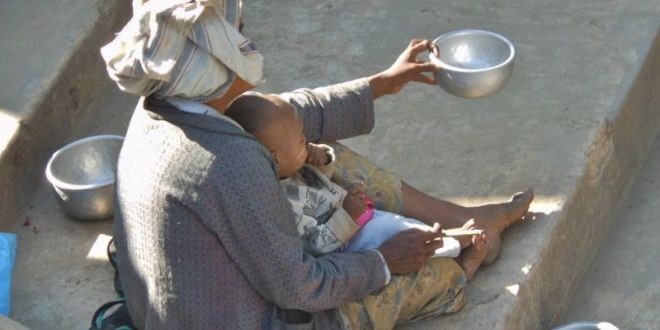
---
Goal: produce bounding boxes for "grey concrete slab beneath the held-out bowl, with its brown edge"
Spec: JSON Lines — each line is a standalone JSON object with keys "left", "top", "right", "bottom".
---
{"left": 245, "top": 1, "right": 660, "bottom": 329}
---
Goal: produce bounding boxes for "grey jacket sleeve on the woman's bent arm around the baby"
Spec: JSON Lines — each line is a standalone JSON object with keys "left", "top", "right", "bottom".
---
{"left": 201, "top": 142, "right": 386, "bottom": 312}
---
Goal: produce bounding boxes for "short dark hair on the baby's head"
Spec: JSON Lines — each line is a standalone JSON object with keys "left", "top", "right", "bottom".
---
{"left": 225, "top": 94, "right": 278, "bottom": 135}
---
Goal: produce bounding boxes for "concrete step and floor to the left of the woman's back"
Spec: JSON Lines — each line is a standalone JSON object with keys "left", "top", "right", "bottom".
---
{"left": 0, "top": 0, "right": 135, "bottom": 329}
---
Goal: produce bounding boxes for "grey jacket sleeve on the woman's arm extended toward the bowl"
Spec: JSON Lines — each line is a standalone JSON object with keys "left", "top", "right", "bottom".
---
{"left": 280, "top": 78, "right": 374, "bottom": 142}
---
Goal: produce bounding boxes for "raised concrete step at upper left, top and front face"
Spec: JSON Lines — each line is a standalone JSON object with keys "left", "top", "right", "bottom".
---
{"left": 0, "top": 0, "right": 130, "bottom": 229}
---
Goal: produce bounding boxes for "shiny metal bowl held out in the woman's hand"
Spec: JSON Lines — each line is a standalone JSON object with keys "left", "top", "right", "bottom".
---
{"left": 429, "top": 30, "right": 516, "bottom": 98}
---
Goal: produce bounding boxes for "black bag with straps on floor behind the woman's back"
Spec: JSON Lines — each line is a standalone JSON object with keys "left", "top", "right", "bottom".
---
{"left": 89, "top": 239, "right": 136, "bottom": 330}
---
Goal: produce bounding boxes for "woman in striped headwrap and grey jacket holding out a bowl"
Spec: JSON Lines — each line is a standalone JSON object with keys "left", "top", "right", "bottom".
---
{"left": 102, "top": 0, "right": 533, "bottom": 329}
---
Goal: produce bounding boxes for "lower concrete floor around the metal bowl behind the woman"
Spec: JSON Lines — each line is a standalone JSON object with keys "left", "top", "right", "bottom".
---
{"left": 11, "top": 79, "right": 137, "bottom": 329}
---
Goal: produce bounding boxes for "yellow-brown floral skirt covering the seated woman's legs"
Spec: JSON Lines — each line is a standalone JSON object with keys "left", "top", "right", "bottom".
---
{"left": 331, "top": 143, "right": 467, "bottom": 329}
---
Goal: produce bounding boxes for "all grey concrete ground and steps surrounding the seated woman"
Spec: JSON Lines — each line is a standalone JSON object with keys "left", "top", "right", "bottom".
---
{"left": 0, "top": 0, "right": 660, "bottom": 329}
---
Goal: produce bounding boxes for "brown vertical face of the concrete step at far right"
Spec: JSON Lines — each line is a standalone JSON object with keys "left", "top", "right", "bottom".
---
{"left": 541, "top": 24, "right": 660, "bottom": 325}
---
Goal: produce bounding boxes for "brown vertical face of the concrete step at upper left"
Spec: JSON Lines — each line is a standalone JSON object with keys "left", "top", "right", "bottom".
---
{"left": 0, "top": 0, "right": 131, "bottom": 230}
